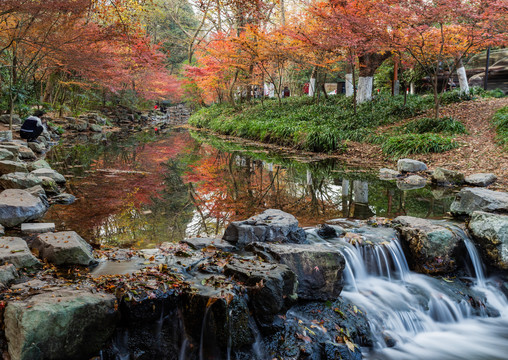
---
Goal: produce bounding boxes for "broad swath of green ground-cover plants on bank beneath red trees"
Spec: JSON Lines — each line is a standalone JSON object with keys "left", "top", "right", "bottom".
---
{"left": 189, "top": 91, "right": 485, "bottom": 156}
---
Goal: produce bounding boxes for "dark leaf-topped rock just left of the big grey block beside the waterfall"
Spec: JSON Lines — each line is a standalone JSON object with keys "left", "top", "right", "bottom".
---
{"left": 224, "top": 260, "right": 298, "bottom": 324}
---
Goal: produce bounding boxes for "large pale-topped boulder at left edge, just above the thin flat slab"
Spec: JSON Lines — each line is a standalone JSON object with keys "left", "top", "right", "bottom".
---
{"left": 0, "top": 189, "right": 47, "bottom": 227}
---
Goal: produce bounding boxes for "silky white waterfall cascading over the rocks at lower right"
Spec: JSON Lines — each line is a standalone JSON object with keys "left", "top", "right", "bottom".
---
{"left": 314, "top": 224, "right": 508, "bottom": 360}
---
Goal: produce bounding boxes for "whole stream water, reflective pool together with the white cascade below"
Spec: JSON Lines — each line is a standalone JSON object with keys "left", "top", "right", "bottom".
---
{"left": 44, "top": 130, "right": 508, "bottom": 360}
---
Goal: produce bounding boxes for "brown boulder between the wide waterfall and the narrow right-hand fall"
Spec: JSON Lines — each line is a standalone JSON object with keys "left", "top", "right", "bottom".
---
{"left": 393, "top": 216, "right": 463, "bottom": 275}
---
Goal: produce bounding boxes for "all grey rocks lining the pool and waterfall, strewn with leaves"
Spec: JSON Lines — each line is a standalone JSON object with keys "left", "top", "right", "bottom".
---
{"left": 0, "top": 119, "right": 508, "bottom": 359}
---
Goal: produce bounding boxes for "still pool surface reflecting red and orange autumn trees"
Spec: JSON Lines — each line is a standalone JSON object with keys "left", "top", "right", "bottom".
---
{"left": 45, "top": 131, "right": 453, "bottom": 248}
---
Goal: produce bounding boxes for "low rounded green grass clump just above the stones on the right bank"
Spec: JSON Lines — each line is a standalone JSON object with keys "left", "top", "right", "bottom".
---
{"left": 381, "top": 133, "right": 459, "bottom": 158}
